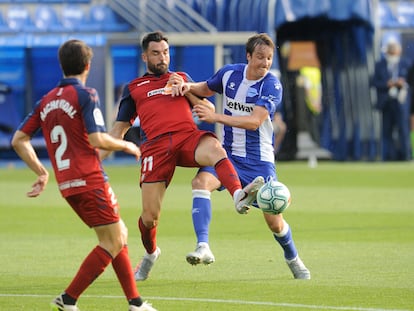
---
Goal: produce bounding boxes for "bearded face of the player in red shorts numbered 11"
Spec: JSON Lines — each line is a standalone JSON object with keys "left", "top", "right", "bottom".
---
{"left": 142, "top": 41, "right": 170, "bottom": 75}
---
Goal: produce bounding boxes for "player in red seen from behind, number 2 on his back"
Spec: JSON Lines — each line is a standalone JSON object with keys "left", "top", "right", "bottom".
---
{"left": 12, "top": 40, "right": 155, "bottom": 311}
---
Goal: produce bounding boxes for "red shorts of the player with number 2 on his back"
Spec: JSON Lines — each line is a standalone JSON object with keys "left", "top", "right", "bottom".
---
{"left": 66, "top": 183, "right": 120, "bottom": 227}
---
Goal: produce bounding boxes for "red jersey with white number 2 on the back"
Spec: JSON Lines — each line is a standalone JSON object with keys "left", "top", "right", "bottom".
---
{"left": 19, "top": 78, "right": 107, "bottom": 197}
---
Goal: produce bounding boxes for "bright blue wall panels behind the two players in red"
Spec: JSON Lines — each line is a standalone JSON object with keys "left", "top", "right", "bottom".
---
{"left": 0, "top": 40, "right": 214, "bottom": 158}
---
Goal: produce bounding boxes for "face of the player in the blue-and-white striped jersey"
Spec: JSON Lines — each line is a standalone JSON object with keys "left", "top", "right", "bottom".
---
{"left": 247, "top": 44, "right": 273, "bottom": 80}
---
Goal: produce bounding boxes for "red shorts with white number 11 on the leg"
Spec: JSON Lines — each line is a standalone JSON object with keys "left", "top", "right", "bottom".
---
{"left": 140, "top": 130, "right": 216, "bottom": 186}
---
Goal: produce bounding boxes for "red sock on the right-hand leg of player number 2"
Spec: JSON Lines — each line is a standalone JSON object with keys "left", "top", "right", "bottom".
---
{"left": 112, "top": 245, "right": 139, "bottom": 300}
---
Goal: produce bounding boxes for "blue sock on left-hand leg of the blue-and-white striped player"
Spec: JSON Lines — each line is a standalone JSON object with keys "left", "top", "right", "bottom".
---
{"left": 191, "top": 190, "right": 211, "bottom": 244}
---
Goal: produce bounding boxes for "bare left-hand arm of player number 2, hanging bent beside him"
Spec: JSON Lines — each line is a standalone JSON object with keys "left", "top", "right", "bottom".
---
{"left": 12, "top": 130, "right": 49, "bottom": 198}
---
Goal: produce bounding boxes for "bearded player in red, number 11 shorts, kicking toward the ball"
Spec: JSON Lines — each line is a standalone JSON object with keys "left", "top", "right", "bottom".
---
{"left": 102, "top": 32, "right": 257, "bottom": 280}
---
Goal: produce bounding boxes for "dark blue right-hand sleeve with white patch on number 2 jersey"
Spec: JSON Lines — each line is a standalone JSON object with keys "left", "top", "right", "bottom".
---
{"left": 78, "top": 88, "right": 106, "bottom": 134}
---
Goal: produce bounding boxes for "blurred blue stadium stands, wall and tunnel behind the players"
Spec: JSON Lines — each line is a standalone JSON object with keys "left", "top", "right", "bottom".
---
{"left": 0, "top": 0, "right": 414, "bottom": 161}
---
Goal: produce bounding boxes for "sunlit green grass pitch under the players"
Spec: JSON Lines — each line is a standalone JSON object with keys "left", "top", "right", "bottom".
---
{"left": 0, "top": 162, "right": 414, "bottom": 311}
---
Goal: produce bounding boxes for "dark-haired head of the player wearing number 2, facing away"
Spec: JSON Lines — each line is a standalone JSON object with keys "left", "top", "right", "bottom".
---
{"left": 58, "top": 39, "right": 93, "bottom": 76}
